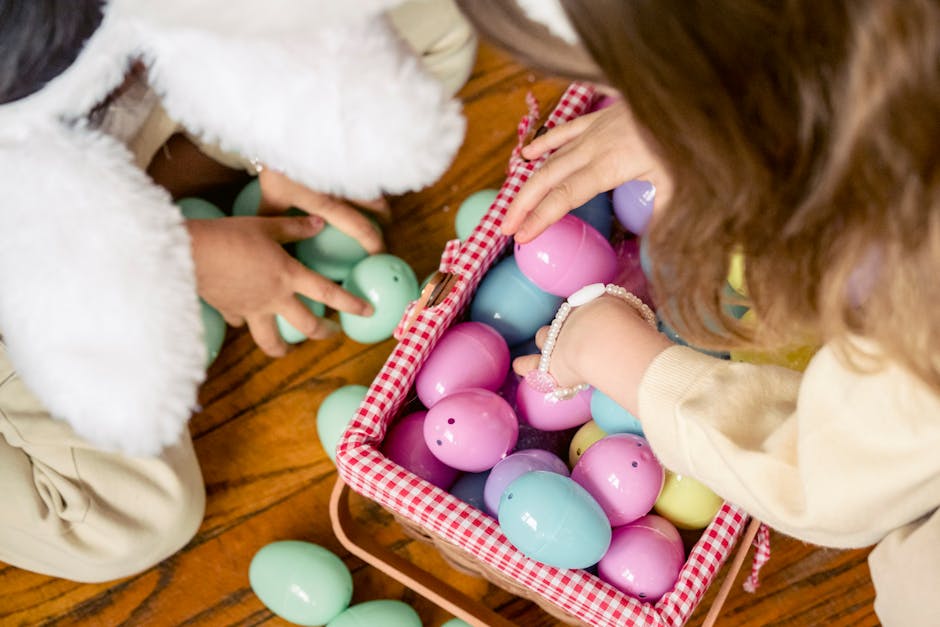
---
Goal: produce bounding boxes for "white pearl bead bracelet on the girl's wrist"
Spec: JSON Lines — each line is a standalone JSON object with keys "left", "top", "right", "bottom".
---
{"left": 525, "top": 283, "right": 656, "bottom": 401}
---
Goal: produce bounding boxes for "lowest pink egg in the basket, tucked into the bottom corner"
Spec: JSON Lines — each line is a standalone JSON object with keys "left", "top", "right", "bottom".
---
{"left": 597, "top": 515, "right": 685, "bottom": 603}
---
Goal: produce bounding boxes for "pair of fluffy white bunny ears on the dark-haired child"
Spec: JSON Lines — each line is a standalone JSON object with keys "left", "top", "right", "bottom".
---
{"left": 0, "top": 0, "right": 464, "bottom": 454}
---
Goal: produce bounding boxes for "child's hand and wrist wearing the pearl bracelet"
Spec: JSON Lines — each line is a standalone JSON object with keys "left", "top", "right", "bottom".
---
{"left": 513, "top": 296, "right": 672, "bottom": 414}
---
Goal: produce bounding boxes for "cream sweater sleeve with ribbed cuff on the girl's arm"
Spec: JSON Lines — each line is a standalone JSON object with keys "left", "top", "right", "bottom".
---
{"left": 639, "top": 346, "right": 940, "bottom": 547}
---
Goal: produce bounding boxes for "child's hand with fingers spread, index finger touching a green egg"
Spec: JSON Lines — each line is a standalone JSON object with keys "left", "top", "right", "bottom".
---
{"left": 186, "top": 216, "right": 372, "bottom": 357}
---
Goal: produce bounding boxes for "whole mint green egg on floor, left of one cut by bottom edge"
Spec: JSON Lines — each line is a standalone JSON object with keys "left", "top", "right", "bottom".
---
{"left": 248, "top": 540, "right": 352, "bottom": 625}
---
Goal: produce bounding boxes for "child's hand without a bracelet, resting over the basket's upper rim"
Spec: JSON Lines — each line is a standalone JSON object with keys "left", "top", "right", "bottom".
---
{"left": 502, "top": 102, "right": 671, "bottom": 244}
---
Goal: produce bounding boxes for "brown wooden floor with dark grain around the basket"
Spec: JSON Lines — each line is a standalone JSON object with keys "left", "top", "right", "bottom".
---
{"left": 0, "top": 46, "right": 878, "bottom": 627}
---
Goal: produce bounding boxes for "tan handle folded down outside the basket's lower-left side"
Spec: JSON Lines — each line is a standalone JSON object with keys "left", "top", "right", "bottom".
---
{"left": 330, "top": 477, "right": 514, "bottom": 627}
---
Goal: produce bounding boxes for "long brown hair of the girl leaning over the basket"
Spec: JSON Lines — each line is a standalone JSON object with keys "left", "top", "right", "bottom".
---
{"left": 462, "top": 0, "right": 940, "bottom": 390}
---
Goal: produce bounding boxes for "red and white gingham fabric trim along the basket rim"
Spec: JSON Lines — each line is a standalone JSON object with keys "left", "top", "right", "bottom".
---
{"left": 336, "top": 84, "right": 747, "bottom": 627}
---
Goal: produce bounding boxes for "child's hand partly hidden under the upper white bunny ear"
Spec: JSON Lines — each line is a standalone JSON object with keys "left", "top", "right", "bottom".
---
{"left": 258, "top": 168, "right": 391, "bottom": 255}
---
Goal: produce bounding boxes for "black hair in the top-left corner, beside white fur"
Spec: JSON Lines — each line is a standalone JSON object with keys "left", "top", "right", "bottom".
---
{"left": 0, "top": 0, "right": 102, "bottom": 104}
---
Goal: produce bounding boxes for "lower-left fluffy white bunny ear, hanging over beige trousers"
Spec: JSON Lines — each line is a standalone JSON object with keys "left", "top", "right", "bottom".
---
{"left": 0, "top": 126, "right": 206, "bottom": 454}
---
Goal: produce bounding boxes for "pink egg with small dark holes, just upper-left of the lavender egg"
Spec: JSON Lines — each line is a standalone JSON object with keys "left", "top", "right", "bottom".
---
{"left": 424, "top": 388, "right": 519, "bottom": 472}
